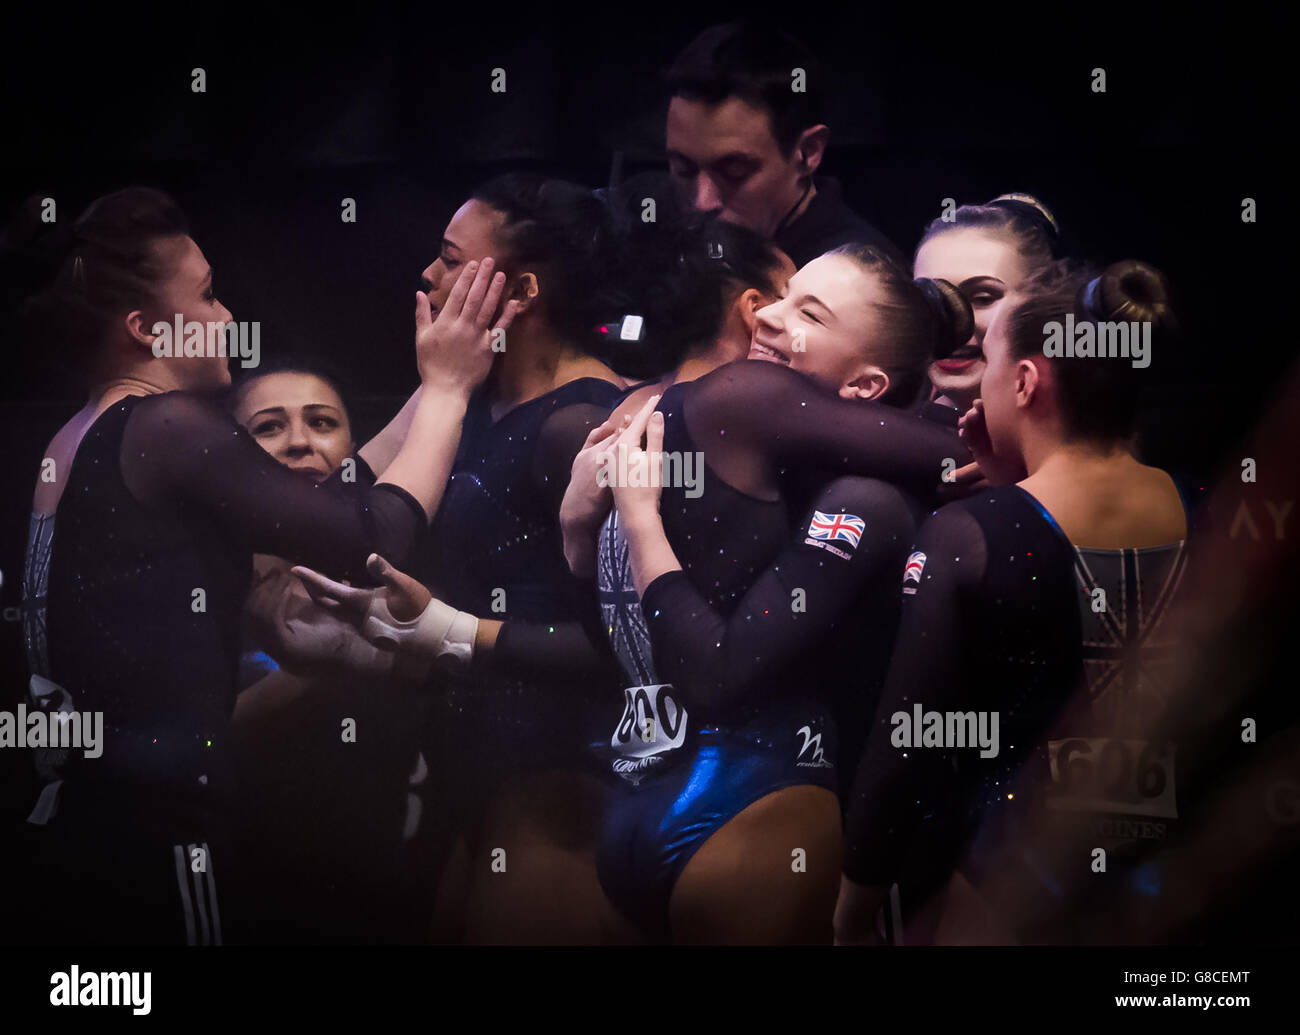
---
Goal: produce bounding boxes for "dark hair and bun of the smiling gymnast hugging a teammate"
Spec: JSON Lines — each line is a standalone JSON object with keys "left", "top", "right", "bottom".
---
{"left": 828, "top": 244, "right": 975, "bottom": 407}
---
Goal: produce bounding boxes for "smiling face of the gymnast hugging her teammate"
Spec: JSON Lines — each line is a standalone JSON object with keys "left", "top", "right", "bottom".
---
{"left": 749, "top": 255, "right": 880, "bottom": 397}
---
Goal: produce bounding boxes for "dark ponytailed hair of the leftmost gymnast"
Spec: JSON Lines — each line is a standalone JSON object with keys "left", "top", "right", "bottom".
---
{"left": 0, "top": 187, "right": 190, "bottom": 365}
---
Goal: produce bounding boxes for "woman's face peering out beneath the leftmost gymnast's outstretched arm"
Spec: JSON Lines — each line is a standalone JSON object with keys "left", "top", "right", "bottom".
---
{"left": 235, "top": 372, "right": 354, "bottom": 481}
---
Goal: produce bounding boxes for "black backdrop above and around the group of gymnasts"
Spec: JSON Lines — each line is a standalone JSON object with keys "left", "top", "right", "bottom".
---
{"left": 0, "top": 3, "right": 1296, "bottom": 798}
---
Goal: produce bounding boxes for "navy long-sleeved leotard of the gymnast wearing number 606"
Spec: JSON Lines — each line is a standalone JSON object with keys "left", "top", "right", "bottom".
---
{"left": 845, "top": 486, "right": 1187, "bottom": 936}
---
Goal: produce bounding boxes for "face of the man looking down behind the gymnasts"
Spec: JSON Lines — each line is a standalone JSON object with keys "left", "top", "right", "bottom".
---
{"left": 667, "top": 98, "right": 820, "bottom": 237}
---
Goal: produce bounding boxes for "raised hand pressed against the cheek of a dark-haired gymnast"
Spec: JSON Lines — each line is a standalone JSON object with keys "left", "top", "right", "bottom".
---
{"left": 415, "top": 257, "right": 519, "bottom": 393}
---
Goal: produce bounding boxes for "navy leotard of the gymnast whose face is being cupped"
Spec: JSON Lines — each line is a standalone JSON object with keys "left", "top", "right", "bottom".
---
{"left": 416, "top": 377, "right": 623, "bottom": 826}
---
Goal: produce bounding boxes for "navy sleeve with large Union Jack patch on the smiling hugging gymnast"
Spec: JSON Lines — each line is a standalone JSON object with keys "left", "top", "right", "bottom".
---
{"left": 641, "top": 476, "right": 923, "bottom": 780}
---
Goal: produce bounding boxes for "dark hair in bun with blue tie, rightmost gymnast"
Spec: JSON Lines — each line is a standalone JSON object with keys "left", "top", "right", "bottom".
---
{"left": 1006, "top": 259, "right": 1178, "bottom": 442}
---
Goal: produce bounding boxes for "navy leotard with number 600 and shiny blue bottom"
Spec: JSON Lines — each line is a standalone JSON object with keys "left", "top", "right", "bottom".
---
{"left": 598, "top": 363, "right": 965, "bottom": 926}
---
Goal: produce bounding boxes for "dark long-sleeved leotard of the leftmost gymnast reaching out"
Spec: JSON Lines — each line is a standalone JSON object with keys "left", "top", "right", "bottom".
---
{"left": 16, "top": 393, "right": 426, "bottom": 940}
